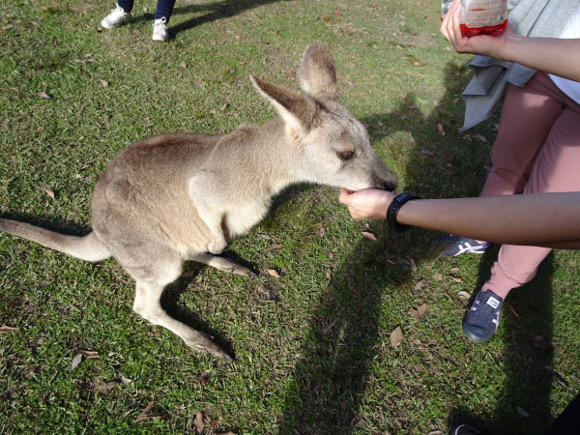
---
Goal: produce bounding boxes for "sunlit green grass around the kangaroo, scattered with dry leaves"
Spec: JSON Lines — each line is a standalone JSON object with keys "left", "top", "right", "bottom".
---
{"left": 0, "top": 0, "right": 580, "bottom": 434}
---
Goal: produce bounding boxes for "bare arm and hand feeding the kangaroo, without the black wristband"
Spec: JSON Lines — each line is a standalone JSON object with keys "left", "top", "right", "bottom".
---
{"left": 339, "top": 189, "right": 580, "bottom": 249}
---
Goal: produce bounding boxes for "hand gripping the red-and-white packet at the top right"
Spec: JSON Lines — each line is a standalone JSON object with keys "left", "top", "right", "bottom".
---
{"left": 441, "top": 0, "right": 515, "bottom": 60}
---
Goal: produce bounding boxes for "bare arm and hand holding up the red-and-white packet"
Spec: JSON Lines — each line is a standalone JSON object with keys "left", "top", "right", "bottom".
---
{"left": 441, "top": 0, "right": 580, "bottom": 81}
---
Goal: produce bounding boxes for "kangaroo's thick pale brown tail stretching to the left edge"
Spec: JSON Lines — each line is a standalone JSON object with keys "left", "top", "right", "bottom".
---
{"left": 0, "top": 219, "right": 111, "bottom": 261}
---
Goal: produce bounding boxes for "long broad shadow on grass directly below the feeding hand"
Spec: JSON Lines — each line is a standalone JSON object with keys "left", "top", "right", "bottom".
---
{"left": 280, "top": 232, "right": 411, "bottom": 435}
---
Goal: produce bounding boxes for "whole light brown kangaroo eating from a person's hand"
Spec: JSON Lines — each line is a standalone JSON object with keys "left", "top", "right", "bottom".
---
{"left": 0, "top": 43, "right": 397, "bottom": 363}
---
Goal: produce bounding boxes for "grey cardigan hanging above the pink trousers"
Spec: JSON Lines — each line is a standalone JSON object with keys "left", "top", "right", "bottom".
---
{"left": 461, "top": 0, "right": 580, "bottom": 131}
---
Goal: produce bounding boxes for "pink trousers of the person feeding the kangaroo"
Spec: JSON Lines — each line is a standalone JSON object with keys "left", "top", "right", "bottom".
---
{"left": 480, "top": 73, "right": 580, "bottom": 298}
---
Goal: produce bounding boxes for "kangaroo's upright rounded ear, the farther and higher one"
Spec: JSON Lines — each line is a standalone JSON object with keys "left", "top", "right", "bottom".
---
{"left": 298, "top": 42, "right": 338, "bottom": 100}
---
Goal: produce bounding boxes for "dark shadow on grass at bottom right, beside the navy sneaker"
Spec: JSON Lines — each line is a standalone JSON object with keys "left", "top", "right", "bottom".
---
{"left": 450, "top": 246, "right": 554, "bottom": 434}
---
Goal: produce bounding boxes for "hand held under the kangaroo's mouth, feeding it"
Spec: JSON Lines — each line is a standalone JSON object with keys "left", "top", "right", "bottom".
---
{"left": 338, "top": 188, "right": 397, "bottom": 220}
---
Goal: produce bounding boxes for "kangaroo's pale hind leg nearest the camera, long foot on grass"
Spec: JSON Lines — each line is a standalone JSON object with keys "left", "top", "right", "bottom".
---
{"left": 124, "top": 247, "right": 232, "bottom": 363}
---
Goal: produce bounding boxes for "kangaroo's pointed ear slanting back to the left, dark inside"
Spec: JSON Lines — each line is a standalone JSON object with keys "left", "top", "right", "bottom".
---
{"left": 250, "top": 76, "right": 317, "bottom": 135}
